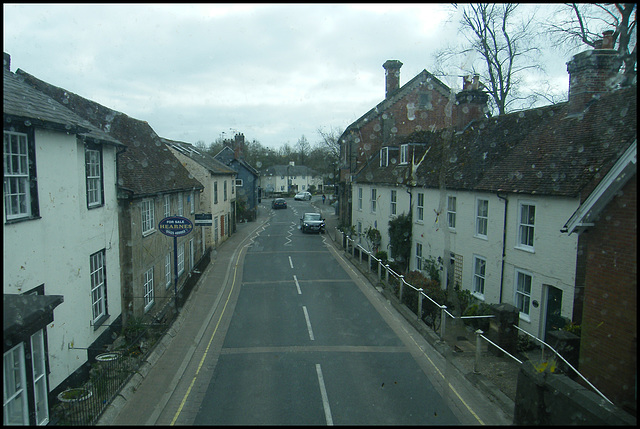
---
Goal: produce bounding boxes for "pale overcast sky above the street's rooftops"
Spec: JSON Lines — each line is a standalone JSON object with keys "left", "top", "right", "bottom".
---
{"left": 3, "top": 4, "right": 570, "bottom": 148}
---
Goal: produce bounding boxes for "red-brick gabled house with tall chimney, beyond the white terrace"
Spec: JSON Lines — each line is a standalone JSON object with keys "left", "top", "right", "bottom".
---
{"left": 338, "top": 60, "right": 488, "bottom": 225}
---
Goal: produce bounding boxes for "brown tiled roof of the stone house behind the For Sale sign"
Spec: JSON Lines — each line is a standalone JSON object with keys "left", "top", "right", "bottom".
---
{"left": 16, "top": 69, "right": 204, "bottom": 198}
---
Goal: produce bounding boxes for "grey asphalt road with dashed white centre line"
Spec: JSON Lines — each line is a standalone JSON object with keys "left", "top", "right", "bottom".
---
{"left": 165, "top": 200, "right": 510, "bottom": 425}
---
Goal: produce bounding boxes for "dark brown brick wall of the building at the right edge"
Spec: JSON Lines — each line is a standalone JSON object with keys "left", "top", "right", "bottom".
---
{"left": 579, "top": 175, "right": 637, "bottom": 414}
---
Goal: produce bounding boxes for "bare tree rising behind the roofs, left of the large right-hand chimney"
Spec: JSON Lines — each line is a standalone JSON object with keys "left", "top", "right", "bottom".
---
{"left": 436, "top": 3, "right": 544, "bottom": 115}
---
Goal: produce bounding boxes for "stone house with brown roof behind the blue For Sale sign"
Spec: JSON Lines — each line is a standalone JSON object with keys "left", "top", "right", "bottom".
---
{"left": 17, "top": 70, "right": 204, "bottom": 344}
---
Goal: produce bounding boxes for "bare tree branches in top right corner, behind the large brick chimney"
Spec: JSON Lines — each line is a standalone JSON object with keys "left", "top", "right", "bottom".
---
{"left": 546, "top": 3, "right": 638, "bottom": 86}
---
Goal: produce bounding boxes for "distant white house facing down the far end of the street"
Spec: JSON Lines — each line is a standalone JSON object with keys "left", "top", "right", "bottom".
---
{"left": 260, "top": 162, "right": 323, "bottom": 196}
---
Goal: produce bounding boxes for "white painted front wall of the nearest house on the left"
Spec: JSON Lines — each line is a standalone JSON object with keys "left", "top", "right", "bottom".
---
{"left": 3, "top": 130, "right": 121, "bottom": 389}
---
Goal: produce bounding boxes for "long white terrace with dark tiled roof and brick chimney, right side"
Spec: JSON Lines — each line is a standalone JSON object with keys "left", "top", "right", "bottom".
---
{"left": 352, "top": 33, "right": 637, "bottom": 354}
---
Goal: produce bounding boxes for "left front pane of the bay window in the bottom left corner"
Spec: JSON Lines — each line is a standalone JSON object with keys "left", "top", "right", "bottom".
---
{"left": 2, "top": 343, "right": 29, "bottom": 425}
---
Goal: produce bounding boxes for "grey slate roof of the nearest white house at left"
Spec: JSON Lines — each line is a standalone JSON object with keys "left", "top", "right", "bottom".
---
{"left": 2, "top": 68, "right": 122, "bottom": 145}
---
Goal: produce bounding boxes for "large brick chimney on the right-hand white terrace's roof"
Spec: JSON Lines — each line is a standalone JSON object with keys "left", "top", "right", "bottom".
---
{"left": 567, "top": 30, "right": 622, "bottom": 113}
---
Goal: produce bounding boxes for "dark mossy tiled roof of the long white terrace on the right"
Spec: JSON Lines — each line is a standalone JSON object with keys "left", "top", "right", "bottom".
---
{"left": 356, "top": 85, "right": 637, "bottom": 200}
